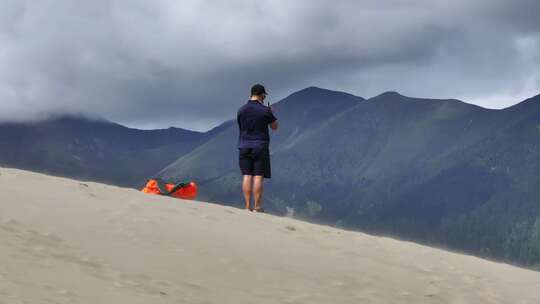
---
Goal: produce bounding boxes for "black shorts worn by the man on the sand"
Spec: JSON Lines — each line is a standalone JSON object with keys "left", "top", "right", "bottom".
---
{"left": 238, "top": 148, "right": 272, "bottom": 178}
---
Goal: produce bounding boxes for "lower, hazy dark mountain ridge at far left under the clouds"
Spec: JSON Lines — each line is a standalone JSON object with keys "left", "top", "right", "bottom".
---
{"left": 0, "top": 116, "right": 212, "bottom": 187}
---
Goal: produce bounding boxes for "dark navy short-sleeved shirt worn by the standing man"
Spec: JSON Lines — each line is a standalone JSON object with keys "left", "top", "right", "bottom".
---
{"left": 236, "top": 100, "right": 276, "bottom": 148}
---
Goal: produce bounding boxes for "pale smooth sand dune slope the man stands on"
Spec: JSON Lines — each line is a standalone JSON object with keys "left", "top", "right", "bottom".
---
{"left": 0, "top": 169, "right": 540, "bottom": 304}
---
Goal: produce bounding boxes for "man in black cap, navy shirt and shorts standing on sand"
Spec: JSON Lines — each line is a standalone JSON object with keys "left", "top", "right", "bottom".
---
{"left": 237, "top": 84, "right": 278, "bottom": 212}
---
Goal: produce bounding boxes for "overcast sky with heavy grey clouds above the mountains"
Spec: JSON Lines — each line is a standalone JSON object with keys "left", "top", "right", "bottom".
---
{"left": 0, "top": 0, "right": 540, "bottom": 130}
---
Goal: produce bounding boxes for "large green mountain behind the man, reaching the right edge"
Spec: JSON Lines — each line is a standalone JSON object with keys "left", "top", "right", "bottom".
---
{"left": 160, "top": 87, "right": 540, "bottom": 265}
